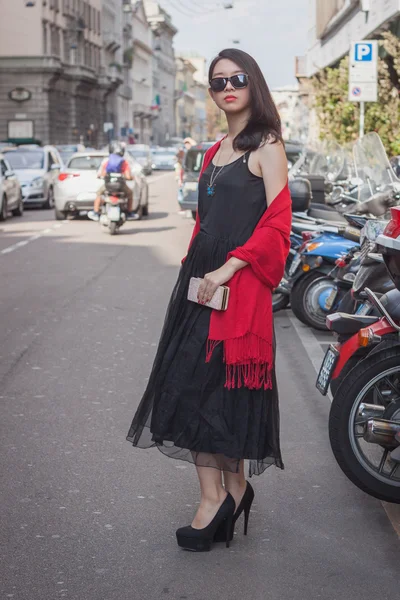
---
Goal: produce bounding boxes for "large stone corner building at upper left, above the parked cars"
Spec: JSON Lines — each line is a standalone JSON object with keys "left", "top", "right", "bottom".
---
{"left": 0, "top": 0, "right": 114, "bottom": 145}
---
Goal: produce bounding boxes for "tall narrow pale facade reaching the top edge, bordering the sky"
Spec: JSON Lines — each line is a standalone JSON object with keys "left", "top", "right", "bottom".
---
{"left": 144, "top": 0, "right": 177, "bottom": 146}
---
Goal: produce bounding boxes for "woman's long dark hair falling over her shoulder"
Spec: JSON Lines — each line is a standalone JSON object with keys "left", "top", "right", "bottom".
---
{"left": 208, "top": 48, "right": 283, "bottom": 152}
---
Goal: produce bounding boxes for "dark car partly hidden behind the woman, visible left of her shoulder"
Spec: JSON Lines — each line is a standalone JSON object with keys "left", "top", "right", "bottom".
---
{"left": 178, "top": 142, "right": 214, "bottom": 219}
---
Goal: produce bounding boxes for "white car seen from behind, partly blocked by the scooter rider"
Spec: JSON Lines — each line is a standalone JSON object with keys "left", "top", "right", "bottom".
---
{"left": 54, "top": 151, "right": 149, "bottom": 220}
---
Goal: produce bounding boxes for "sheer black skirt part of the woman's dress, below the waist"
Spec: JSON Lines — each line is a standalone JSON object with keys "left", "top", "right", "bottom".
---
{"left": 127, "top": 233, "right": 283, "bottom": 476}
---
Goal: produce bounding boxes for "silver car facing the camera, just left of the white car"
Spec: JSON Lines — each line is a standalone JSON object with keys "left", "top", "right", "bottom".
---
{"left": 4, "top": 146, "right": 64, "bottom": 208}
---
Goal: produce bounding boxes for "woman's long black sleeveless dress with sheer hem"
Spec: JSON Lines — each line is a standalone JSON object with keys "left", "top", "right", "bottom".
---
{"left": 126, "top": 153, "right": 283, "bottom": 476}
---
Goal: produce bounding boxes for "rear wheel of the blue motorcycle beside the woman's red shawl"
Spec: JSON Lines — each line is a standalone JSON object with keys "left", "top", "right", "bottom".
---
{"left": 290, "top": 271, "right": 333, "bottom": 331}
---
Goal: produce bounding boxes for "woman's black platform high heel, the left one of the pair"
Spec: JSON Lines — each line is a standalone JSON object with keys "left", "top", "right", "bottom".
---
{"left": 176, "top": 493, "right": 235, "bottom": 552}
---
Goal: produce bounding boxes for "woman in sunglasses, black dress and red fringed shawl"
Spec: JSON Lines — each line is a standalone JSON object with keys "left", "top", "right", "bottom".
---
{"left": 127, "top": 49, "right": 291, "bottom": 551}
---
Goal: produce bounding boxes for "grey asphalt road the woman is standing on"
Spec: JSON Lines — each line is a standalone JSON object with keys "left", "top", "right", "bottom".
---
{"left": 0, "top": 174, "right": 400, "bottom": 600}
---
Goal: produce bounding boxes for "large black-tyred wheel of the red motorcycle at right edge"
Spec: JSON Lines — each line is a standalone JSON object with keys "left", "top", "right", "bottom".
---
{"left": 329, "top": 347, "right": 400, "bottom": 504}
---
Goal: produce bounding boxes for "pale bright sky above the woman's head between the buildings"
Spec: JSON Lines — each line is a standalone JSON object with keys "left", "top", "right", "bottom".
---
{"left": 159, "top": 0, "right": 310, "bottom": 88}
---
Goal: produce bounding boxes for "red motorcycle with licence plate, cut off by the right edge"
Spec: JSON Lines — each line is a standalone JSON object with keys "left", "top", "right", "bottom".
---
{"left": 317, "top": 207, "right": 400, "bottom": 504}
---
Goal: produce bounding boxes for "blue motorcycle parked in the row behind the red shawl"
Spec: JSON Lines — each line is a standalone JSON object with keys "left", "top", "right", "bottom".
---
{"left": 285, "top": 227, "right": 360, "bottom": 330}
